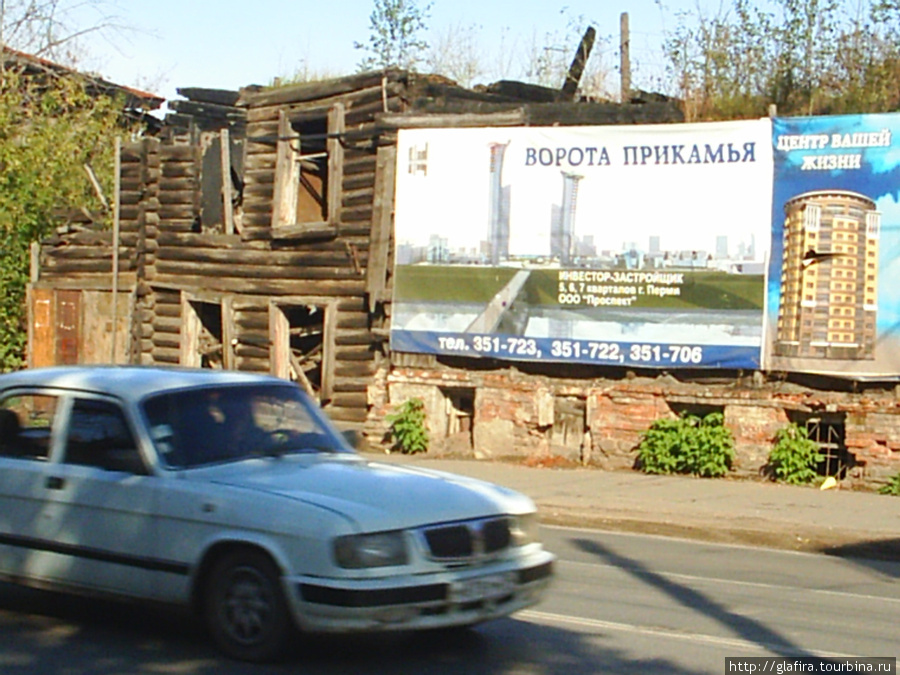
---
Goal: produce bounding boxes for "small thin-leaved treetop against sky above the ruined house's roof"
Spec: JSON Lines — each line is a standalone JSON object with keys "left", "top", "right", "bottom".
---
{"left": 353, "top": 0, "right": 431, "bottom": 71}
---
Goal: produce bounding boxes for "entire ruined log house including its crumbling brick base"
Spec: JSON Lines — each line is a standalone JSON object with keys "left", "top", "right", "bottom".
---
{"left": 29, "top": 70, "right": 900, "bottom": 484}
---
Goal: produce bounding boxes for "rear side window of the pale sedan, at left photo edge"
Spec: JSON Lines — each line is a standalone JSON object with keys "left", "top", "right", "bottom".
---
{"left": 0, "top": 393, "right": 58, "bottom": 461}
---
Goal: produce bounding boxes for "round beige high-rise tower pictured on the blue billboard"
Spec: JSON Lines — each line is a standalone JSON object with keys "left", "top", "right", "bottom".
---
{"left": 774, "top": 190, "right": 881, "bottom": 360}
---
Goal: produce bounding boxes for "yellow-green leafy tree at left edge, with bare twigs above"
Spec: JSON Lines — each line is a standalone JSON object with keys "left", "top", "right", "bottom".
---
{"left": 0, "top": 0, "right": 132, "bottom": 371}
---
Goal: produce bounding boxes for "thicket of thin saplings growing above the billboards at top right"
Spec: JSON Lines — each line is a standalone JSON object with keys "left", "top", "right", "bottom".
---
{"left": 664, "top": 0, "right": 900, "bottom": 120}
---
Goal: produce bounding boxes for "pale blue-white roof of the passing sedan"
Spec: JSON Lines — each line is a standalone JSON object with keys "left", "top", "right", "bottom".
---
{"left": 0, "top": 366, "right": 290, "bottom": 400}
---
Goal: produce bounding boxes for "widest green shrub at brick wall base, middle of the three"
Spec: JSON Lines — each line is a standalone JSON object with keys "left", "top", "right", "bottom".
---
{"left": 637, "top": 413, "right": 734, "bottom": 478}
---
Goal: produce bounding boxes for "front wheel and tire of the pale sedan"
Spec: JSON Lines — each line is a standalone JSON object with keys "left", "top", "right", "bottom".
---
{"left": 204, "top": 550, "right": 295, "bottom": 663}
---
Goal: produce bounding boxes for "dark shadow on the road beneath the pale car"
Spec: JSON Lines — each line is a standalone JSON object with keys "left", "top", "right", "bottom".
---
{"left": 0, "top": 583, "right": 716, "bottom": 675}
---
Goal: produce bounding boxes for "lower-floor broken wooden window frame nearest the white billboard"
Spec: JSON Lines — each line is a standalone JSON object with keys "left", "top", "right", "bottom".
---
{"left": 269, "top": 296, "right": 338, "bottom": 405}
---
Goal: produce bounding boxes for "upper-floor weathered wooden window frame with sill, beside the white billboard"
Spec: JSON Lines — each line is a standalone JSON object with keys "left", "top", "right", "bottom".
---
{"left": 272, "top": 103, "right": 345, "bottom": 239}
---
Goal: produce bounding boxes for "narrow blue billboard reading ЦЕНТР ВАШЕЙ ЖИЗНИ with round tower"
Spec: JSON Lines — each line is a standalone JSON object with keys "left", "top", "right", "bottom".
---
{"left": 765, "top": 114, "right": 900, "bottom": 379}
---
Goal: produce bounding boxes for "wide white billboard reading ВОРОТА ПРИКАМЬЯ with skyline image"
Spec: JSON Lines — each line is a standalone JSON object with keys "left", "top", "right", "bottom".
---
{"left": 391, "top": 124, "right": 773, "bottom": 369}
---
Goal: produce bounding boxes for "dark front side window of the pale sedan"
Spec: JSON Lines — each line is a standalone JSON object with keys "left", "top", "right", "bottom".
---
{"left": 63, "top": 398, "right": 147, "bottom": 474}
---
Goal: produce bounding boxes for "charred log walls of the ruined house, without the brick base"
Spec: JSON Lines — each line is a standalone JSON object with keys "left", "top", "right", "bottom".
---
{"left": 29, "top": 70, "right": 680, "bottom": 426}
